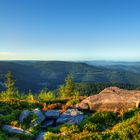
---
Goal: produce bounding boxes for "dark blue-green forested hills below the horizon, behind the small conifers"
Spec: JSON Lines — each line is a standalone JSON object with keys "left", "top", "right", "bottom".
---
{"left": 0, "top": 61, "right": 140, "bottom": 91}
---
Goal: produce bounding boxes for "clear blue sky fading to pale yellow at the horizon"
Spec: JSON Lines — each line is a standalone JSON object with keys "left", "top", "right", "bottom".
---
{"left": 0, "top": 0, "right": 140, "bottom": 61}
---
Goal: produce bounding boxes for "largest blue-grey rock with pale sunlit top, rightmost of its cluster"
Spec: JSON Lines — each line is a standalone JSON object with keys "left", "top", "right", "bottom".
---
{"left": 56, "top": 109, "right": 84, "bottom": 125}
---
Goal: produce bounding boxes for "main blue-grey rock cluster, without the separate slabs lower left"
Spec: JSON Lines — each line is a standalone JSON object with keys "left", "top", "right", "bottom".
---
{"left": 19, "top": 109, "right": 84, "bottom": 129}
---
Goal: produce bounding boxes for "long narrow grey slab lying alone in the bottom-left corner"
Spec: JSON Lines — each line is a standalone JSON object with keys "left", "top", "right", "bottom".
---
{"left": 2, "top": 125, "right": 34, "bottom": 136}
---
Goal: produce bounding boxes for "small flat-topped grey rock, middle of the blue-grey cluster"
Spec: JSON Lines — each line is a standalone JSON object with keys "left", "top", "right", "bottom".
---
{"left": 45, "top": 110, "right": 60, "bottom": 119}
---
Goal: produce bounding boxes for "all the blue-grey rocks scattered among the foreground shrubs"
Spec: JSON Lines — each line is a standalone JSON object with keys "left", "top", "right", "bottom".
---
{"left": 2, "top": 109, "right": 84, "bottom": 140}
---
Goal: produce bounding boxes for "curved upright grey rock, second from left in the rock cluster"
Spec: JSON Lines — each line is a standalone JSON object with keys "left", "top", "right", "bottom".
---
{"left": 32, "top": 108, "right": 46, "bottom": 124}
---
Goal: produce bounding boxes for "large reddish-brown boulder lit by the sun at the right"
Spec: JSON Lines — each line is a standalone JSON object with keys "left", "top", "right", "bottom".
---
{"left": 76, "top": 87, "right": 140, "bottom": 112}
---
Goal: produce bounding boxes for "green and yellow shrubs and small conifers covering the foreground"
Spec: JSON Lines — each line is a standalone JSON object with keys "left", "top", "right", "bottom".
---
{"left": 0, "top": 71, "right": 140, "bottom": 140}
